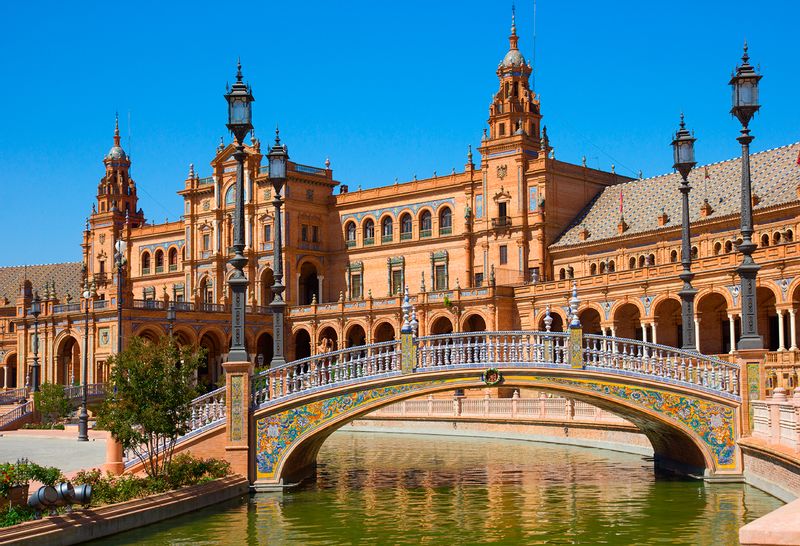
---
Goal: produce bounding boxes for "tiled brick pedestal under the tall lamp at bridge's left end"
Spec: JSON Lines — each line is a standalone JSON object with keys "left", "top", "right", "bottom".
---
{"left": 222, "top": 362, "right": 253, "bottom": 478}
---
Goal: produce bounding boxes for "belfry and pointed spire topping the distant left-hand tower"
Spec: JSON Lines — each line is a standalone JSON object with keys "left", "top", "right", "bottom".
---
{"left": 97, "top": 116, "right": 143, "bottom": 224}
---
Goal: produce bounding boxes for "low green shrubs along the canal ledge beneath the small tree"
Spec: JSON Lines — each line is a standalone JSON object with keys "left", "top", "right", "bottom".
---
{"left": 72, "top": 454, "right": 230, "bottom": 506}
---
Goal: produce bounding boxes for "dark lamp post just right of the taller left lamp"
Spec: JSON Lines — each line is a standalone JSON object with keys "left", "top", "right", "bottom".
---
{"left": 267, "top": 127, "right": 289, "bottom": 368}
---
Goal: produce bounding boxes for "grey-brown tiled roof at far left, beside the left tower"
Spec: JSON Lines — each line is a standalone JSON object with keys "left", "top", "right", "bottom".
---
{"left": 0, "top": 262, "right": 82, "bottom": 307}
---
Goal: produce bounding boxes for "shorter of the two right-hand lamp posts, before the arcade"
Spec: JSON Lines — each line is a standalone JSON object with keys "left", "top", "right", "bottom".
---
{"left": 672, "top": 113, "right": 697, "bottom": 351}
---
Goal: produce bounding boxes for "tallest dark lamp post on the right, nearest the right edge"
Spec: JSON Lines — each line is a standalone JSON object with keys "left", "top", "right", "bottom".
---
{"left": 729, "top": 42, "right": 764, "bottom": 350}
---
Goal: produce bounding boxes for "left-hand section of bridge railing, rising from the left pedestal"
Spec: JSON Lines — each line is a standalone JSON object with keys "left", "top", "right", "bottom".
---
{"left": 252, "top": 340, "right": 400, "bottom": 406}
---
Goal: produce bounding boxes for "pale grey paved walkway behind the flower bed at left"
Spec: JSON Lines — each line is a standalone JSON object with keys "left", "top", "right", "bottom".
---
{"left": 0, "top": 429, "right": 106, "bottom": 473}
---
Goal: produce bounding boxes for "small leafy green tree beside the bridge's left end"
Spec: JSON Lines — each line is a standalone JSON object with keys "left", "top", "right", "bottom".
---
{"left": 97, "top": 337, "right": 205, "bottom": 477}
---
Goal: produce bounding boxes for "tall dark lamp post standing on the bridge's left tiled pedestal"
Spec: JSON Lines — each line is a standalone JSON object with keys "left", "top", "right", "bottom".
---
{"left": 225, "top": 59, "right": 255, "bottom": 362}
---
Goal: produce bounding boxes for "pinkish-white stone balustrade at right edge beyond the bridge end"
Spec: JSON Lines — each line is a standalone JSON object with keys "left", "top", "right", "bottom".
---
{"left": 750, "top": 387, "right": 800, "bottom": 451}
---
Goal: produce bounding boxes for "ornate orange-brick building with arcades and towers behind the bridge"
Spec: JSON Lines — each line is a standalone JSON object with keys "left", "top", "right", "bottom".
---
{"left": 0, "top": 15, "right": 800, "bottom": 387}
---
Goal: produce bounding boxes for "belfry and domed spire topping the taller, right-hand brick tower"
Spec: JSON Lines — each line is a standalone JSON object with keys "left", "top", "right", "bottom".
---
{"left": 488, "top": 9, "right": 542, "bottom": 144}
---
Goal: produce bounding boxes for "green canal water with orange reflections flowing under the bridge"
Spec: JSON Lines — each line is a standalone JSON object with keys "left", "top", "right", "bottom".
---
{"left": 98, "top": 432, "right": 783, "bottom": 545}
